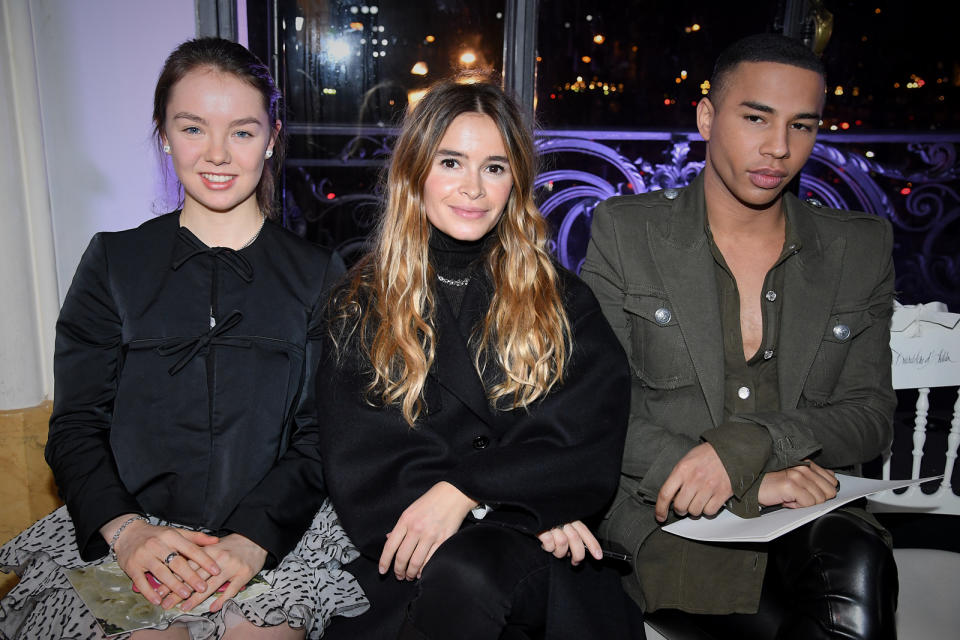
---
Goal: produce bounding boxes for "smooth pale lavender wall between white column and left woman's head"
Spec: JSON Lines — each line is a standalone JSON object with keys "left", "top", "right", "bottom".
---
{"left": 30, "top": 0, "right": 196, "bottom": 300}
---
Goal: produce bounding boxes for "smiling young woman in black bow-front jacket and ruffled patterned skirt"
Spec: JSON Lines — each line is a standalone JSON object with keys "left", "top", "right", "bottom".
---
{"left": 0, "top": 38, "right": 366, "bottom": 638}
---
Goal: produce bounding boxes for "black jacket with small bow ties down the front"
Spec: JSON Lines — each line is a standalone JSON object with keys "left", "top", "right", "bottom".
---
{"left": 46, "top": 214, "right": 343, "bottom": 564}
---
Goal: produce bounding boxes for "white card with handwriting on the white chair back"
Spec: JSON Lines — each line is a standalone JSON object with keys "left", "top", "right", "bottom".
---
{"left": 890, "top": 302, "right": 960, "bottom": 389}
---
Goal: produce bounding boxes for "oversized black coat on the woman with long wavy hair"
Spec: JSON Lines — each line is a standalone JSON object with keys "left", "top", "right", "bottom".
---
{"left": 317, "top": 270, "right": 630, "bottom": 637}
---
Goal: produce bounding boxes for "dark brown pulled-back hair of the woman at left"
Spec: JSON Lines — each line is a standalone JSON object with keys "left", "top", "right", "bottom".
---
{"left": 153, "top": 38, "right": 286, "bottom": 218}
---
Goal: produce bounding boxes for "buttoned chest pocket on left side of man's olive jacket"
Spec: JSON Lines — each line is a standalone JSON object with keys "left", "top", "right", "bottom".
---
{"left": 623, "top": 294, "right": 695, "bottom": 389}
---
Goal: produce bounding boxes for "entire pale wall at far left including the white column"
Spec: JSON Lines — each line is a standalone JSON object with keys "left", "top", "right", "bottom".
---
{"left": 0, "top": 0, "right": 195, "bottom": 410}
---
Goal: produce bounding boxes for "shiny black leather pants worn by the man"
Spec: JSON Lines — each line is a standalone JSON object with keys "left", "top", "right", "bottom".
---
{"left": 658, "top": 511, "right": 898, "bottom": 640}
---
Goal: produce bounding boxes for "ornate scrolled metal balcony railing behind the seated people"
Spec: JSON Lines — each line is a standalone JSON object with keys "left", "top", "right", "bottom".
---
{"left": 286, "top": 124, "right": 960, "bottom": 310}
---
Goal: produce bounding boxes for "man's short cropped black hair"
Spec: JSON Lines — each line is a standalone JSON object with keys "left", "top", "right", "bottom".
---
{"left": 710, "top": 33, "right": 826, "bottom": 102}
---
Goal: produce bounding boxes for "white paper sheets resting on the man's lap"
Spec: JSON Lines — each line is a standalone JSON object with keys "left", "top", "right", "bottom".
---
{"left": 663, "top": 473, "right": 943, "bottom": 542}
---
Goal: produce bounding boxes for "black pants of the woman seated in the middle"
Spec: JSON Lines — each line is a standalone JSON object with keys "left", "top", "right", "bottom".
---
{"left": 323, "top": 524, "right": 644, "bottom": 640}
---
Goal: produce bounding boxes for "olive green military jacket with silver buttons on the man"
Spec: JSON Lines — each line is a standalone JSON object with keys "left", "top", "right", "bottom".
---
{"left": 581, "top": 177, "right": 896, "bottom": 612}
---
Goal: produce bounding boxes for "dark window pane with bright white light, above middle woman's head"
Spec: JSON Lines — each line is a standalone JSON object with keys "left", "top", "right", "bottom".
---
{"left": 279, "top": 0, "right": 504, "bottom": 125}
